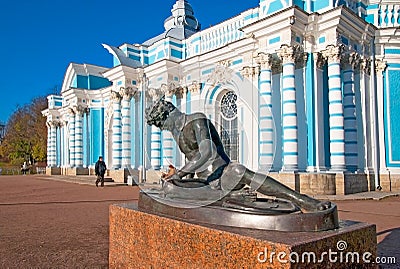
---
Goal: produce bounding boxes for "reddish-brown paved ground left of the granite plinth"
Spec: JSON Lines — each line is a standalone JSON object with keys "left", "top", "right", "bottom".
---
{"left": 0, "top": 176, "right": 138, "bottom": 268}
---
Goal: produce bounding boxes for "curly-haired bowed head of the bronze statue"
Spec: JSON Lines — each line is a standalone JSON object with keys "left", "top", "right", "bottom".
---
{"left": 146, "top": 97, "right": 176, "bottom": 128}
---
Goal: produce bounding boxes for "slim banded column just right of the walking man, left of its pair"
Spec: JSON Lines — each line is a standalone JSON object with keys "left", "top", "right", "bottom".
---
{"left": 111, "top": 92, "right": 122, "bottom": 169}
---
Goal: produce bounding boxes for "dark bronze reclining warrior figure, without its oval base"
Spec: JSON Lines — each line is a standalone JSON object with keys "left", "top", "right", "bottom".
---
{"left": 146, "top": 98, "right": 332, "bottom": 212}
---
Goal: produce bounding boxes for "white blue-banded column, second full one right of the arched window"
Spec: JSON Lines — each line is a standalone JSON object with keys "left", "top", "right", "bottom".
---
{"left": 277, "top": 45, "right": 298, "bottom": 171}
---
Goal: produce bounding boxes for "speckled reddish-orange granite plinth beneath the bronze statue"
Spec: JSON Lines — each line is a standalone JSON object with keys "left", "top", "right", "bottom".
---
{"left": 109, "top": 204, "right": 376, "bottom": 269}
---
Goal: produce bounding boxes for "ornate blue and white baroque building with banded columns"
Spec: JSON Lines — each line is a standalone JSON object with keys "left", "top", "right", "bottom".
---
{"left": 43, "top": 0, "right": 400, "bottom": 194}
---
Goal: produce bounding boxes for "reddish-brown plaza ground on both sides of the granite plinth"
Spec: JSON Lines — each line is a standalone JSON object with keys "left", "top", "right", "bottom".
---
{"left": 0, "top": 176, "right": 400, "bottom": 268}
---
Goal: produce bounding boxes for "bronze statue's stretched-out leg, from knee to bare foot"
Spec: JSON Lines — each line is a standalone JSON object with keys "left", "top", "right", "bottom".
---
{"left": 221, "top": 161, "right": 331, "bottom": 211}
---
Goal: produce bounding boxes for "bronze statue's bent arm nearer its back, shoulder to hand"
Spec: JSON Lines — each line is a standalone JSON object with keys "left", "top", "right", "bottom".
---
{"left": 178, "top": 119, "right": 215, "bottom": 178}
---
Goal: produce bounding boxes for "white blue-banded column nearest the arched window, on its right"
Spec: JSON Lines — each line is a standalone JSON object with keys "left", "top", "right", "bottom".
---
{"left": 256, "top": 53, "right": 275, "bottom": 170}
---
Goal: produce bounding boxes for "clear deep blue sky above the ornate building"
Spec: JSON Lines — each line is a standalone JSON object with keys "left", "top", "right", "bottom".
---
{"left": 0, "top": 0, "right": 259, "bottom": 122}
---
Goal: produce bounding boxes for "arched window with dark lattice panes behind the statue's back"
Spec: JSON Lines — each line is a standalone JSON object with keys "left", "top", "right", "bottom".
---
{"left": 220, "top": 91, "right": 239, "bottom": 161}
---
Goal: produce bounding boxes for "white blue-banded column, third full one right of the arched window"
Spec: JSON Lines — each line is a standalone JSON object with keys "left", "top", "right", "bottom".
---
{"left": 323, "top": 45, "right": 346, "bottom": 171}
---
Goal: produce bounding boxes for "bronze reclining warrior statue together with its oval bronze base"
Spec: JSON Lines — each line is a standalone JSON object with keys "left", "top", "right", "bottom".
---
{"left": 139, "top": 98, "right": 339, "bottom": 231}
